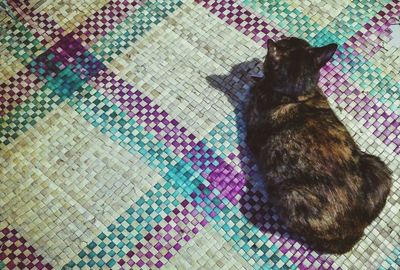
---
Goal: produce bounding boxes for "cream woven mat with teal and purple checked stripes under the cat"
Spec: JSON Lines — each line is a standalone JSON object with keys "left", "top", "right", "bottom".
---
{"left": 0, "top": 0, "right": 400, "bottom": 269}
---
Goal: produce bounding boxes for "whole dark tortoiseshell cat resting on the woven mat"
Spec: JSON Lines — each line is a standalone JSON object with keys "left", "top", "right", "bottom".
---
{"left": 247, "top": 38, "right": 391, "bottom": 253}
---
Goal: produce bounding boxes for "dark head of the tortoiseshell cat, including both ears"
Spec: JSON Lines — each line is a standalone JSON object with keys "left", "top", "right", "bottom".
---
{"left": 264, "top": 37, "right": 337, "bottom": 96}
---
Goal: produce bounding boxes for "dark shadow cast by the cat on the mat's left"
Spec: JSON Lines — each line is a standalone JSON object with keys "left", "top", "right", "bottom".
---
{"left": 207, "top": 59, "right": 307, "bottom": 249}
